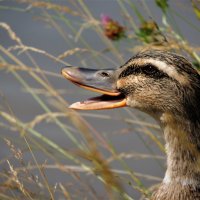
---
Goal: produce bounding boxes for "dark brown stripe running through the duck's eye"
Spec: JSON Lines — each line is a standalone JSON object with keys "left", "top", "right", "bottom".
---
{"left": 119, "top": 64, "right": 168, "bottom": 79}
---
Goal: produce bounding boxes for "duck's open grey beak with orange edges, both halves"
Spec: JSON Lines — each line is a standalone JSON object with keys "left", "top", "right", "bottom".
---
{"left": 61, "top": 67, "right": 126, "bottom": 110}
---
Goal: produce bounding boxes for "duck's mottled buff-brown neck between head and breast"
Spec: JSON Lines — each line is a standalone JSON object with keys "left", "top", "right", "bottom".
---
{"left": 161, "top": 113, "right": 200, "bottom": 186}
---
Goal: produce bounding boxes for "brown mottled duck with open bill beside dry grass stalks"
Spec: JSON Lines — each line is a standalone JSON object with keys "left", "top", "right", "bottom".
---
{"left": 61, "top": 50, "right": 200, "bottom": 200}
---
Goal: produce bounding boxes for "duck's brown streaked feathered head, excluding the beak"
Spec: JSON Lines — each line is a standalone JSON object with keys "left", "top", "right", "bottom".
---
{"left": 117, "top": 50, "right": 200, "bottom": 117}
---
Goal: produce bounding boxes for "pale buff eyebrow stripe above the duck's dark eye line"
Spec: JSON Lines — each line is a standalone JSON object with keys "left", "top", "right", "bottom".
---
{"left": 133, "top": 58, "right": 189, "bottom": 85}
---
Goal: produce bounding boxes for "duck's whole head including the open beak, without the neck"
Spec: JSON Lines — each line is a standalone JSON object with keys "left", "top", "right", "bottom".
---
{"left": 62, "top": 50, "right": 200, "bottom": 120}
